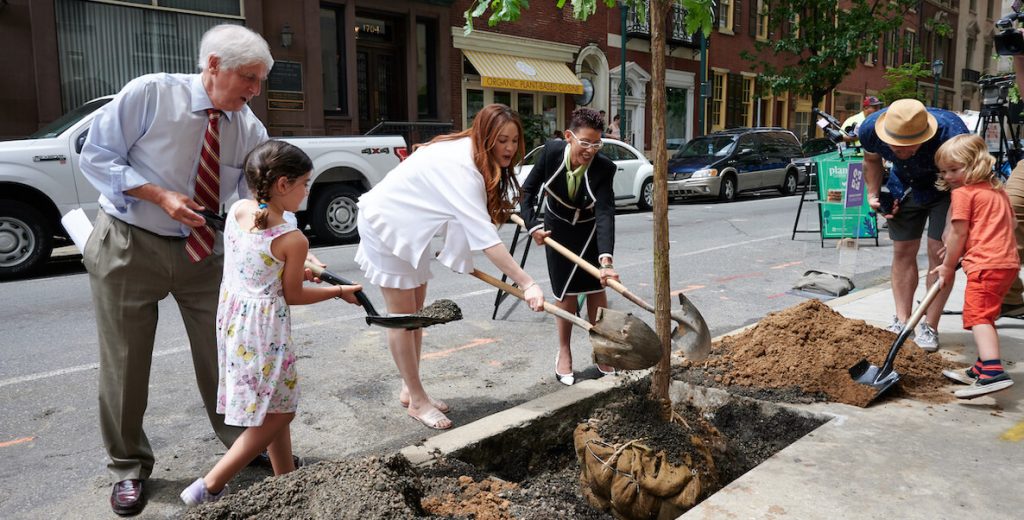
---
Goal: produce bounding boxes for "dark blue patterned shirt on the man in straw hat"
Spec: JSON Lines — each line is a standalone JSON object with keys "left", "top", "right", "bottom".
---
{"left": 857, "top": 109, "right": 968, "bottom": 204}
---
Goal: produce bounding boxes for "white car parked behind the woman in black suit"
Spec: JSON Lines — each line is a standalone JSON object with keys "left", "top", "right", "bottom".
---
{"left": 515, "top": 138, "right": 654, "bottom": 211}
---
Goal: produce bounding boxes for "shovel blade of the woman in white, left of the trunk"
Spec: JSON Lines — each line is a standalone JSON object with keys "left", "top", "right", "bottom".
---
{"left": 590, "top": 307, "right": 663, "bottom": 371}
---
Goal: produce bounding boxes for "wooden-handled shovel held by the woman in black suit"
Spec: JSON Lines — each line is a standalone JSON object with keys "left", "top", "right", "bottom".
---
{"left": 511, "top": 211, "right": 711, "bottom": 362}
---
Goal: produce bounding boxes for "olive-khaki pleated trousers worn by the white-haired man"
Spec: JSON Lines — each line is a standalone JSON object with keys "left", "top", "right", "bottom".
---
{"left": 83, "top": 210, "right": 244, "bottom": 481}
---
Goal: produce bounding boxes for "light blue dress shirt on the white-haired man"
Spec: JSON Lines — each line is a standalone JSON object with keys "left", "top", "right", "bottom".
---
{"left": 80, "top": 74, "right": 268, "bottom": 237}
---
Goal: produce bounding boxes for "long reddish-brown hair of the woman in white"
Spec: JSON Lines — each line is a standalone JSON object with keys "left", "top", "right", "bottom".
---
{"left": 413, "top": 103, "right": 526, "bottom": 224}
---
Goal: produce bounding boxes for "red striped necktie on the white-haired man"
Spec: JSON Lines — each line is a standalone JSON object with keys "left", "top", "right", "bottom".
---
{"left": 185, "top": 109, "right": 220, "bottom": 262}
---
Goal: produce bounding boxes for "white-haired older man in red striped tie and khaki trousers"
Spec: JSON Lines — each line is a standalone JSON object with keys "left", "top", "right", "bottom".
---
{"left": 81, "top": 25, "right": 273, "bottom": 515}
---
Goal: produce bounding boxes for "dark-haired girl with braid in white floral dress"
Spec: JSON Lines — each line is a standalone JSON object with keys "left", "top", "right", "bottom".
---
{"left": 181, "top": 140, "right": 361, "bottom": 506}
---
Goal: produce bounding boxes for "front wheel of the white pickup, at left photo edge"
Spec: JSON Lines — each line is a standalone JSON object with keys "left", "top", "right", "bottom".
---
{"left": 0, "top": 201, "right": 53, "bottom": 279}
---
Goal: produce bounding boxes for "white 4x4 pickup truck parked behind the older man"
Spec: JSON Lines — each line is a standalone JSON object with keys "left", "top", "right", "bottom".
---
{"left": 0, "top": 96, "right": 407, "bottom": 279}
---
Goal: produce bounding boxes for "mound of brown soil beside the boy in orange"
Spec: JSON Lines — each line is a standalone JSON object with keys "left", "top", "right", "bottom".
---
{"left": 674, "top": 300, "right": 967, "bottom": 406}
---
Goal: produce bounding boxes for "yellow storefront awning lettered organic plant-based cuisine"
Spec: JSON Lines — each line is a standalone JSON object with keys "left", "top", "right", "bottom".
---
{"left": 462, "top": 50, "right": 583, "bottom": 94}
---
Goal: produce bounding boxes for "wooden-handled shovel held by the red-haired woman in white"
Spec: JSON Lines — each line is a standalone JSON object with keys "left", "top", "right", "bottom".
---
{"left": 471, "top": 270, "right": 662, "bottom": 371}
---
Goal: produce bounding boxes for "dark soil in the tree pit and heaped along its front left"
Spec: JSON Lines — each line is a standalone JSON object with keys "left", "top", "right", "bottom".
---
{"left": 185, "top": 378, "right": 825, "bottom": 520}
